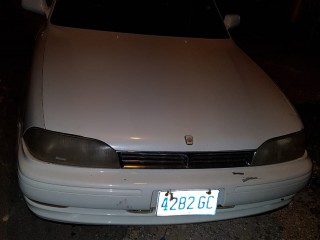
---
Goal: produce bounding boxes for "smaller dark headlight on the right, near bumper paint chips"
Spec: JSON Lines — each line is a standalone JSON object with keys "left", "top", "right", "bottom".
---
{"left": 252, "top": 131, "right": 305, "bottom": 166}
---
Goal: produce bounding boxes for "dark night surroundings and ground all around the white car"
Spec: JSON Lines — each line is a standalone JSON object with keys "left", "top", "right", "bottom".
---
{"left": 0, "top": 0, "right": 320, "bottom": 240}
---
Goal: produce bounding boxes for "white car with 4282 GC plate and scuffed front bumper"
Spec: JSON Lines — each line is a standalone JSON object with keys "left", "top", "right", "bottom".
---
{"left": 18, "top": 0, "right": 312, "bottom": 224}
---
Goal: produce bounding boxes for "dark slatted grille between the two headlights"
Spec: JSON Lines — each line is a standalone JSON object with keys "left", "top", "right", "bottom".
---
{"left": 118, "top": 150, "right": 255, "bottom": 169}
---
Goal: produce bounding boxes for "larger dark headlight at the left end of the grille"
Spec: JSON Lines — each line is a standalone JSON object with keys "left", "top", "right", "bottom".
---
{"left": 23, "top": 128, "right": 120, "bottom": 168}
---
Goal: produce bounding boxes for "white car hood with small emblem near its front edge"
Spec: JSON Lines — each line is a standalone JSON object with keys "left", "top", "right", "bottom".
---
{"left": 42, "top": 25, "right": 302, "bottom": 151}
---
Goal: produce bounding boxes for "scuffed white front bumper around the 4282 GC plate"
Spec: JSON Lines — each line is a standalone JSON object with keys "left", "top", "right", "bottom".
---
{"left": 18, "top": 141, "right": 312, "bottom": 225}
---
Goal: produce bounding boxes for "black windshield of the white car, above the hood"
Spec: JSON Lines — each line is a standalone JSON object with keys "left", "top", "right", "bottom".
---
{"left": 51, "top": 0, "right": 229, "bottom": 38}
